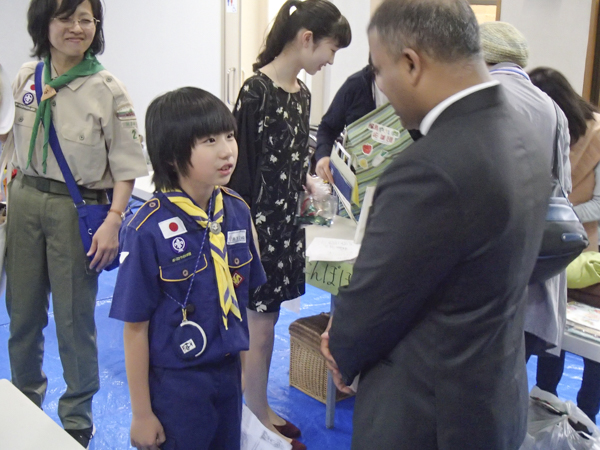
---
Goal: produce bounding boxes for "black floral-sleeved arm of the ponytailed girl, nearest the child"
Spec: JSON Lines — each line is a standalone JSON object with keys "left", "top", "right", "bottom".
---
{"left": 227, "top": 79, "right": 267, "bottom": 207}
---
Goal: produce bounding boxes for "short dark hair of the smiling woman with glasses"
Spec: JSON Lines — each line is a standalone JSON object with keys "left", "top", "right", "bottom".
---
{"left": 27, "top": 0, "right": 104, "bottom": 59}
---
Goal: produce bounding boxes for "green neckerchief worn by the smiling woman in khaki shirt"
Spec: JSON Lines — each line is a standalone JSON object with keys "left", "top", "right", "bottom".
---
{"left": 25, "top": 50, "right": 104, "bottom": 173}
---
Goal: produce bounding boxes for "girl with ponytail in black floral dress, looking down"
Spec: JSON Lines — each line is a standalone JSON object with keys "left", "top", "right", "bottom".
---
{"left": 229, "top": 0, "right": 351, "bottom": 449}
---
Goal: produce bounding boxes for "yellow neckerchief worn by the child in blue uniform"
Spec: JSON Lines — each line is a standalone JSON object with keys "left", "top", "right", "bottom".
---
{"left": 163, "top": 187, "right": 242, "bottom": 329}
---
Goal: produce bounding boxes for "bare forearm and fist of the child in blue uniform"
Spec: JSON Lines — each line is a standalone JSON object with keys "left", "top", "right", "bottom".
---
{"left": 123, "top": 322, "right": 166, "bottom": 450}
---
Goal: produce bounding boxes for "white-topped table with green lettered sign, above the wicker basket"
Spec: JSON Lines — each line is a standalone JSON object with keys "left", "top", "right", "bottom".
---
{"left": 306, "top": 216, "right": 356, "bottom": 428}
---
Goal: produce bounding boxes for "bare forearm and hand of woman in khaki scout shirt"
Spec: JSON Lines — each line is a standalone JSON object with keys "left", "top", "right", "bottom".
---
{"left": 87, "top": 180, "right": 134, "bottom": 272}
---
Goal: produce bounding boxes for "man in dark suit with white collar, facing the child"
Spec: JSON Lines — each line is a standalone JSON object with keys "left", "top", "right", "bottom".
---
{"left": 322, "top": 0, "right": 551, "bottom": 450}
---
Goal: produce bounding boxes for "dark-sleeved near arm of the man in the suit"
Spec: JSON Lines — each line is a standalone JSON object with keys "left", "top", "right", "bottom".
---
{"left": 329, "top": 159, "right": 466, "bottom": 385}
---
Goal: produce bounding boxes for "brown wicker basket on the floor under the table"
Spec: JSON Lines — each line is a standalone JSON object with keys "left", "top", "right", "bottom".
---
{"left": 290, "top": 313, "right": 351, "bottom": 403}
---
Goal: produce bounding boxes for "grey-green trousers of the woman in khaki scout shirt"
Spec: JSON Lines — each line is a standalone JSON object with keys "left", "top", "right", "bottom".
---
{"left": 5, "top": 176, "right": 100, "bottom": 429}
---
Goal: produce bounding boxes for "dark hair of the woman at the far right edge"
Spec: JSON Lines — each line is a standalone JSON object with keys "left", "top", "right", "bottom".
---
{"left": 529, "top": 67, "right": 597, "bottom": 145}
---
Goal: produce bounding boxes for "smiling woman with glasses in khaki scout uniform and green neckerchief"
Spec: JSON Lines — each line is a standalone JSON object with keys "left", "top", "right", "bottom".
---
{"left": 6, "top": 0, "right": 147, "bottom": 447}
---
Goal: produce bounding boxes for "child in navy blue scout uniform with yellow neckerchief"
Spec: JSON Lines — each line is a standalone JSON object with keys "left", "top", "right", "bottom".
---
{"left": 110, "top": 88, "right": 265, "bottom": 450}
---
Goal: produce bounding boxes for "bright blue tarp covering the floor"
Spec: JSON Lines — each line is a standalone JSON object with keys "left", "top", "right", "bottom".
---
{"left": 0, "top": 270, "right": 582, "bottom": 450}
